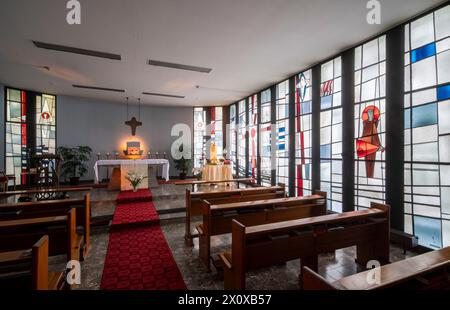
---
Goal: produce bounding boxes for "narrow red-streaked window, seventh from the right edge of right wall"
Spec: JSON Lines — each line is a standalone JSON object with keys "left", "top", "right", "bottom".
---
{"left": 248, "top": 95, "right": 258, "bottom": 179}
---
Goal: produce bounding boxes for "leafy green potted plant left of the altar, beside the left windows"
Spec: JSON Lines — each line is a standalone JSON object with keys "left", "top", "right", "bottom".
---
{"left": 58, "top": 146, "right": 92, "bottom": 185}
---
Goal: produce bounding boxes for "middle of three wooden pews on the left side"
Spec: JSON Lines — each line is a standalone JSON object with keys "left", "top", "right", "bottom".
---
{"left": 0, "top": 209, "right": 84, "bottom": 261}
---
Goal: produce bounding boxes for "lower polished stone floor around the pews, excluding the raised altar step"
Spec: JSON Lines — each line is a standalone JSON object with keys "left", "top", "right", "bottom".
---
{"left": 77, "top": 221, "right": 415, "bottom": 290}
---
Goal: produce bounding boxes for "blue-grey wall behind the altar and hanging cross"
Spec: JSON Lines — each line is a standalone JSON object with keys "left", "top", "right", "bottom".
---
{"left": 57, "top": 96, "right": 193, "bottom": 180}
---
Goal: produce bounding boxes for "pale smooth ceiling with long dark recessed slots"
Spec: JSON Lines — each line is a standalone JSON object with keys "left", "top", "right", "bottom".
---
{"left": 0, "top": 0, "right": 442, "bottom": 106}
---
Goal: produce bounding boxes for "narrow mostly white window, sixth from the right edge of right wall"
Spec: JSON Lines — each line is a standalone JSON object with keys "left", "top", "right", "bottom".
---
{"left": 259, "top": 89, "right": 275, "bottom": 186}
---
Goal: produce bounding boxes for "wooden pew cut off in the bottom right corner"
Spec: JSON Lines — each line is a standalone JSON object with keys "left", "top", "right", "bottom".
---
{"left": 302, "top": 247, "right": 450, "bottom": 290}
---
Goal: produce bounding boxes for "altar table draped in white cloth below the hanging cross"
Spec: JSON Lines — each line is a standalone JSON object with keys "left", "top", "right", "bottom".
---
{"left": 94, "top": 159, "right": 170, "bottom": 190}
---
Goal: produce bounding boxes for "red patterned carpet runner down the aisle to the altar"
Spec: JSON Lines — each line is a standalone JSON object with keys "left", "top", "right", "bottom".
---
{"left": 100, "top": 190, "right": 186, "bottom": 290}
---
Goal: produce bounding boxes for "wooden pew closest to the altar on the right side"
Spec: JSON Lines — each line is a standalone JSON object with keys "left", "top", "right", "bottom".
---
{"left": 184, "top": 186, "right": 286, "bottom": 245}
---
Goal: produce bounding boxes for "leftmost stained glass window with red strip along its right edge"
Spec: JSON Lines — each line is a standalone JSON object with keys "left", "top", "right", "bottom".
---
{"left": 5, "top": 88, "right": 27, "bottom": 185}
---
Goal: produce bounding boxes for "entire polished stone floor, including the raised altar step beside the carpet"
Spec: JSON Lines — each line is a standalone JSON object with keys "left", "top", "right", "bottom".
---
{"left": 60, "top": 184, "right": 415, "bottom": 290}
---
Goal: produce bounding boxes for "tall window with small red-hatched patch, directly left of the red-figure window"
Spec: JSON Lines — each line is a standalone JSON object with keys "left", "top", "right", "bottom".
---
{"left": 320, "top": 57, "right": 342, "bottom": 212}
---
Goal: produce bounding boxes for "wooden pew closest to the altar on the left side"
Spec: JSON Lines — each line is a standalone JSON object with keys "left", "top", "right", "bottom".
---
{"left": 0, "top": 192, "right": 91, "bottom": 258}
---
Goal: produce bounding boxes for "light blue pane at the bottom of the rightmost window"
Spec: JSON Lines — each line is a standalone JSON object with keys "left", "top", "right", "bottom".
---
{"left": 414, "top": 216, "right": 442, "bottom": 249}
